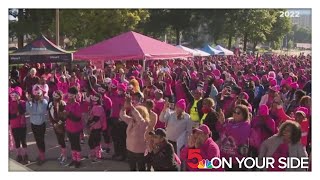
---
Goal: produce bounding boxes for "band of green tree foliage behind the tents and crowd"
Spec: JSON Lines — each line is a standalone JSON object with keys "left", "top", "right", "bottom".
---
{"left": 9, "top": 9, "right": 296, "bottom": 50}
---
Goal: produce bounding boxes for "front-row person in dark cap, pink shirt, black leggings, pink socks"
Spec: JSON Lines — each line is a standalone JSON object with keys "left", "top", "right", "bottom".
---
{"left": 65, "top": 87, "right": 83, "bottom": 168}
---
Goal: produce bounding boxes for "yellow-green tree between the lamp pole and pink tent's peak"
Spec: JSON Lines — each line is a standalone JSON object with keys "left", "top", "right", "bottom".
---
{"left": 60, "top": 9, "right": 149, "bottom": 48}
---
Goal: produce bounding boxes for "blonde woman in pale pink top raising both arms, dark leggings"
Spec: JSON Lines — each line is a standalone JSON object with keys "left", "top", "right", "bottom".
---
{"left": 120, "top": 97, "right": 150, "bottom": 171}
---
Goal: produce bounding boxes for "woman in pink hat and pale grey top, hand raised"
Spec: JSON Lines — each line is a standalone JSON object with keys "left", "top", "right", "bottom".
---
{"left": 159, "top": 99, "right": 192, "bottom": 152}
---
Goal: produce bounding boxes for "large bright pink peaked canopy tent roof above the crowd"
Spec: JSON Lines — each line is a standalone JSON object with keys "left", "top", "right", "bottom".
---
{"left": 74, "top": 31, "right": 192, "bottom": 61}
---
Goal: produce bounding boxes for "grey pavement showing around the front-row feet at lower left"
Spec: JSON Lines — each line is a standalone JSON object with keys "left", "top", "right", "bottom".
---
{"left": 9, "top": 121, "right": 129, "bottom": 171}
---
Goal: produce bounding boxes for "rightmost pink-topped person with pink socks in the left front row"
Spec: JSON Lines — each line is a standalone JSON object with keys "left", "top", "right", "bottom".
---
{"left": 87, "top": 94, "right": 107, "bottom": 163}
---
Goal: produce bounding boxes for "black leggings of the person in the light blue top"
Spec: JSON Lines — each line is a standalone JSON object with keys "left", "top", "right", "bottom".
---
{"left": 31, "top": 123, "right": 46, "bottom": 152}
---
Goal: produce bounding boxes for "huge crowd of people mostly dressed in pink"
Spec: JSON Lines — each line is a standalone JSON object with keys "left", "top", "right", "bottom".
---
{"left": 9, "top": 54, "right": 311, "bottom": 171}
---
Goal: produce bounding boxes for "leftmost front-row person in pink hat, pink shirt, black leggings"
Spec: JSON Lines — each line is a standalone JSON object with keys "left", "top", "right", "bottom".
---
{"left": 9, "top": 86, "right": 29, "bottom": 164}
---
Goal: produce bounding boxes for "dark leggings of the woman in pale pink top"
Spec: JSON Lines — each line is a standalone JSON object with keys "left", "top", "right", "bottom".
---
{"left": 127, "top": 150, "right": 146, "bottom": 171}
